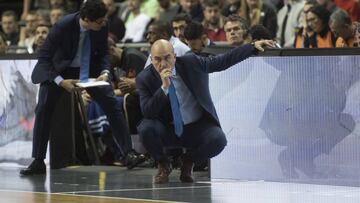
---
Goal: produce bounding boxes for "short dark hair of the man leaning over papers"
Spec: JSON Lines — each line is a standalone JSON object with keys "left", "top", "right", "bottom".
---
{"left": 80, "top": 0, "right": 107, "bottom": 21}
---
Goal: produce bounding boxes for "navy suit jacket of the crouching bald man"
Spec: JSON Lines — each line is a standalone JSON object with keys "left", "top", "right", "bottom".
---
{"left": 136, "top": 44, "right": 257, "bottom": 126}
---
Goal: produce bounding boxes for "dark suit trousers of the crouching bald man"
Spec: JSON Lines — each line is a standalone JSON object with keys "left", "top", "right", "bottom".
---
{"left": 138, "top": 116, "right": 227, "bottom": 163}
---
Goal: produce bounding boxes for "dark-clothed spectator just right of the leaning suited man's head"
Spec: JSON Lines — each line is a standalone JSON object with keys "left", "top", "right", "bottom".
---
{"left": 103, "top": 0, "right": 125, "bottom": 39}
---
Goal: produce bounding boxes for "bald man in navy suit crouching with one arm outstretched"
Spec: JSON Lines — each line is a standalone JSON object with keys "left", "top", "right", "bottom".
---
{"left": 136, "top": 40, "right": 273, "bottom": 184}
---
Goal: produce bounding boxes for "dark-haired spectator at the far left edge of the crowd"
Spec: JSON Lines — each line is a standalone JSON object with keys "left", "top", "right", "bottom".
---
{"left": 1, "top": 10, "right": 19, "bottom": 45}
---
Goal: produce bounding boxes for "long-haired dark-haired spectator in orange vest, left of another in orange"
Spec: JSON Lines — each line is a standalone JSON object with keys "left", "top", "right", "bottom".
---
{"left": 304, "top": 6, "right": 335, "bottom": 48}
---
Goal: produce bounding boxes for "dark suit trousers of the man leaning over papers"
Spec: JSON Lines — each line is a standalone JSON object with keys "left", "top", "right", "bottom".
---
{"left": 32, "top": 69, "right": 131, "bottom": 159}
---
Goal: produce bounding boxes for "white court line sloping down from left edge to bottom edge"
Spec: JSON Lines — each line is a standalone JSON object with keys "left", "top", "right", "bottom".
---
{"left": 0, "top": 190, "right": 183, "bottom": 203}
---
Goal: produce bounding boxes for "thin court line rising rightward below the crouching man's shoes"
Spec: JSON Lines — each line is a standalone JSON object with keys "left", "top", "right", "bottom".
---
{"left": 52, "top": 185, "right": 211, "bottom": 194}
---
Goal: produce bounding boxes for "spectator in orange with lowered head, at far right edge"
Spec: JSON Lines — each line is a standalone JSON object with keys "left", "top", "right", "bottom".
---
{"left": 329, "top": 9, "right": 360, "bottom": 47}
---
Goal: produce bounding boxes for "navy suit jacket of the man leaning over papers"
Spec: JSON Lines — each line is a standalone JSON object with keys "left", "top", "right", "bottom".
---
{"left": 31, "top": 13, "right": 109, "bottom": 84}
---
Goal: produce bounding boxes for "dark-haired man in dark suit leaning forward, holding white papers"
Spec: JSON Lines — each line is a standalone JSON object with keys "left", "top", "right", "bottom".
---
{"left": 20, "top": 0, "right": 141, "bottom": 175}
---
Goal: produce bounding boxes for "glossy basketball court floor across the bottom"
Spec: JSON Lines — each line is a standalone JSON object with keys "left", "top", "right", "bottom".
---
{"left": 0, "top": 166, "right": 360, "bottom": 203}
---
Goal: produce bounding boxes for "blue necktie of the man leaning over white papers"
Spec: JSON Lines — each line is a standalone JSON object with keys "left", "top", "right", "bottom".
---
{"left": 80, "top": 31, "right": 91, "bottom": 82}
